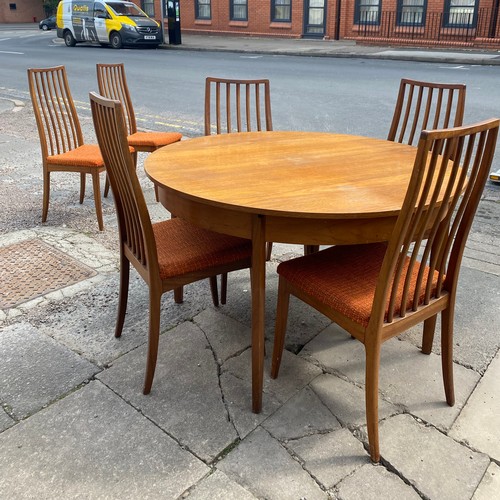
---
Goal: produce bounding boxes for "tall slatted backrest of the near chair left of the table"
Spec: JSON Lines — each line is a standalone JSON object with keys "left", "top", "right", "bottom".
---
{"left": 90, "top": 92, "right": 158, "bottom": 277}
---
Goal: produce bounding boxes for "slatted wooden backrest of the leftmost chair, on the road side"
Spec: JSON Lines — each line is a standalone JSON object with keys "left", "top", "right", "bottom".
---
{"left": 28, "top": 66, "right": 83, "bottom": 159}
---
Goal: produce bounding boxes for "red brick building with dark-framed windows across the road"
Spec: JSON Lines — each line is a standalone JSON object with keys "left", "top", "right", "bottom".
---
{"left": 140, "top": 0, "right": 500, "bottom": 48}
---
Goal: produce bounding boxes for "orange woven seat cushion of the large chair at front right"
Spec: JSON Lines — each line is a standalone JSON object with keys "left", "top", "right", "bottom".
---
{"left": 277, "top": 243, "right": 438, "bottom": 327}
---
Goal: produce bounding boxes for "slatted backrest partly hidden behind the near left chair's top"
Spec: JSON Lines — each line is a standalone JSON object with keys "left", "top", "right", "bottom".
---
{"left": 96, "top": 63, "right": 137, "bottom": 135}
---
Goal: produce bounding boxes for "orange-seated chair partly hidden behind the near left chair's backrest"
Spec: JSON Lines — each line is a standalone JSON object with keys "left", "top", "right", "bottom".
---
{"left": 96, "top": 63, "right": 182, "bottom": 201}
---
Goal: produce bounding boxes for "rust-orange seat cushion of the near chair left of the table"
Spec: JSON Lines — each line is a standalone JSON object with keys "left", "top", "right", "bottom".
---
{"left": 153, "top": 218, "right": 252, "bottom": 279}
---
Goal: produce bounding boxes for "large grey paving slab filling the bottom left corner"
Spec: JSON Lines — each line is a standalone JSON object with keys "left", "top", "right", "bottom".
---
{"left": 0, "top": 382, "right": 209, "bottom": 499}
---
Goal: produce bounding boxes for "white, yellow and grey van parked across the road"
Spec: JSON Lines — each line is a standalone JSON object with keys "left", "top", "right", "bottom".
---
{"left": 57, "top": 0, "right": 163, "bottom": 49}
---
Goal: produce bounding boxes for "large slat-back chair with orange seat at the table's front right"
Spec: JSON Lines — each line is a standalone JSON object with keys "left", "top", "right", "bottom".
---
{"left": 271, "top": 119, "right": 500, "bottom": 462}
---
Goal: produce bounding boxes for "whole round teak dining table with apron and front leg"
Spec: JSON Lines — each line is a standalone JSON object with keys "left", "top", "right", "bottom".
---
{"left": 145, "top": 132, "right": 416, "bottom": 413}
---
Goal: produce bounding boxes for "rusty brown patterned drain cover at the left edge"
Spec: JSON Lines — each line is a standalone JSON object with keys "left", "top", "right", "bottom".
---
{"left": 0, "top": 239, "right": 97, "bottom": 309}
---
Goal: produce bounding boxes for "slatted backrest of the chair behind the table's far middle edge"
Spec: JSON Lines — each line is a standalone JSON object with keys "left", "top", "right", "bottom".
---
{"left": 205, "top": 77, "right": 273, "bottom": 135}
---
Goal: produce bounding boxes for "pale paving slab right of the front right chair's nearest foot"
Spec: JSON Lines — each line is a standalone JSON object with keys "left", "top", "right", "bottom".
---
{"left": 380, "top": 415, "right": 490, "bottom": 500}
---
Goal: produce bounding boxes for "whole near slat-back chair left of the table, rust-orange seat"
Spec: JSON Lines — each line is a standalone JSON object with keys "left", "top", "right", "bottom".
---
{"left": 90, "top": 92, "right": 252, "bottom": 394}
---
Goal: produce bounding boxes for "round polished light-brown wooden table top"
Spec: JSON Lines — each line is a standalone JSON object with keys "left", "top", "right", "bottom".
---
{"left": 145, "top": 132, "right": 416, "bottom": 219}
